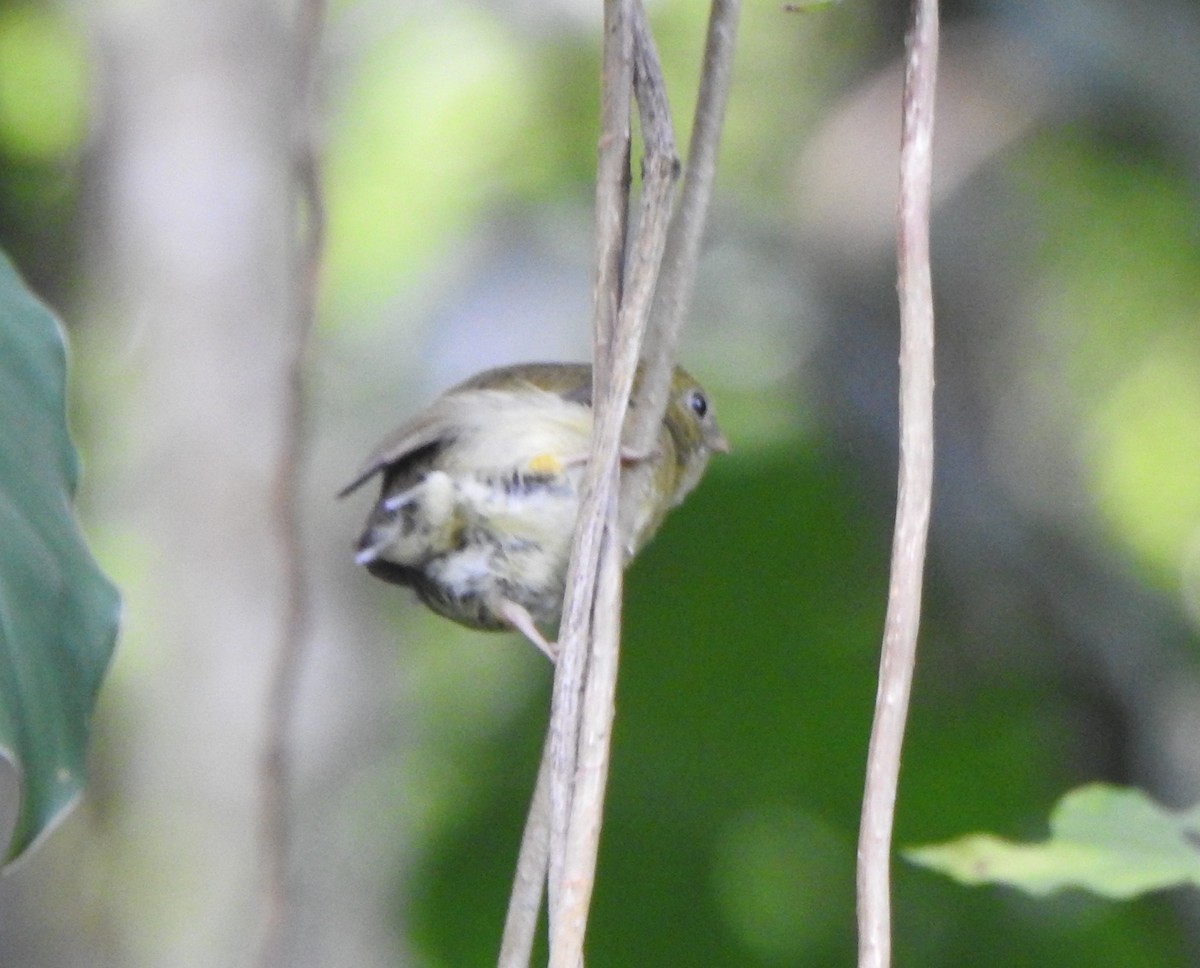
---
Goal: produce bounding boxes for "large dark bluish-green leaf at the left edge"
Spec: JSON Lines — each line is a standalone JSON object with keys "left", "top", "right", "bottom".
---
{"left": 0, "top": 254, "right": 120, "bottom": 862}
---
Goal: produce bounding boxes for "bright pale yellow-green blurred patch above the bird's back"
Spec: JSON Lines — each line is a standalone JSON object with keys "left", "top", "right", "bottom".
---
{"left": 326, "top": 5, "right": 539, "bottom": 318}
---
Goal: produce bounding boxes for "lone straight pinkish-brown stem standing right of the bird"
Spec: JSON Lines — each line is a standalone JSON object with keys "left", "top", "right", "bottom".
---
{"left": 858, "top": 0, "right": 937, "bottom": 968}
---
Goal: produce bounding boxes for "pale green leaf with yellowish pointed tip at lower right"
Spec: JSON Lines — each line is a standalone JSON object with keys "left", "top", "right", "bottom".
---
{"left": 904, "top": 783, "right": 1200, "bottom": 898}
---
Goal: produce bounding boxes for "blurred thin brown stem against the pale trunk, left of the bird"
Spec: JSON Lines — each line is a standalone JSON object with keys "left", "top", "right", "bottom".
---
{"left": 259, "top": 0, "right": 325, "bottom": 968}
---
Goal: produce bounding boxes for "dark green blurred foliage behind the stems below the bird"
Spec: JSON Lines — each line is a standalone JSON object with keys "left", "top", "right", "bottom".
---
{"left": 404, "top": 450, "right": 1186, "bottom": 968}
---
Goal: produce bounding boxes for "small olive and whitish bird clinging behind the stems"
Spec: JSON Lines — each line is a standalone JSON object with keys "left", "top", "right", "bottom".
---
{"left": 338, "top": 363, "right": 730, "bottom": 661}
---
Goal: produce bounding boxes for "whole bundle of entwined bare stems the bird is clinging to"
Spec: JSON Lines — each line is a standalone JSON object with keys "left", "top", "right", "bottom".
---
{"left": 499, "top": 0, "right": 739, "bottom": 968}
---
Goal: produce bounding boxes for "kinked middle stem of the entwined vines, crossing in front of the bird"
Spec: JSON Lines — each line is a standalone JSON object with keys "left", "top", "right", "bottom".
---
{"left": 550, "top": 0, "right": 678, "bottom": 968}
